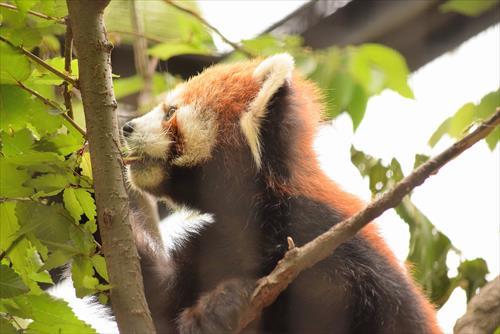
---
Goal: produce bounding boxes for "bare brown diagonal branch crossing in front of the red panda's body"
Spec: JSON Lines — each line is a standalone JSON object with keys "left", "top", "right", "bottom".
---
{"left": 239, "top": 108, "right": 500, "bottom": 330}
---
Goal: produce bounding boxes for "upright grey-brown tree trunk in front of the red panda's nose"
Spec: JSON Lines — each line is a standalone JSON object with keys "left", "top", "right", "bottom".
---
{"left": 66, "top": 0, "right": 155, "bottom": 333}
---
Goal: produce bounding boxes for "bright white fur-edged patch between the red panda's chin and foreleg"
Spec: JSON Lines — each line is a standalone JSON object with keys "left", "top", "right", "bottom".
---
{"left": 160, "top": 207, "right": 214, "bottom": 254}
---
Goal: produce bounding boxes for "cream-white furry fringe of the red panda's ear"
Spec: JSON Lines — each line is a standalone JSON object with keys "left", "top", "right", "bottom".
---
{"left": 240, "top": 53, "right": 294, "bottom": 168}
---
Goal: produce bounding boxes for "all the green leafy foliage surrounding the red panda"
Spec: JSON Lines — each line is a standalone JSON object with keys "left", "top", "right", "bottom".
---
{"left": 0, "top": 0, "right": 500, "bottom": 333}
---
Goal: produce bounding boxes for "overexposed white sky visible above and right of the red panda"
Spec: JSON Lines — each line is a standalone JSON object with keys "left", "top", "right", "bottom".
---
{"left": 199, "top": 0, "right": 500, "bottom": 333}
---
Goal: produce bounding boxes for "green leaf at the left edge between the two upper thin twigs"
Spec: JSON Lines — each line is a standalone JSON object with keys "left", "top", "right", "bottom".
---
{"left": 0, "top": 41, "right": 31, "bottom": 84}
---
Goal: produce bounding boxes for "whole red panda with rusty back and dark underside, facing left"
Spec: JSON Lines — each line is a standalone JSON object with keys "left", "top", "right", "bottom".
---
{"left": 123, "top": 54, "right": 440, "bottom": 333}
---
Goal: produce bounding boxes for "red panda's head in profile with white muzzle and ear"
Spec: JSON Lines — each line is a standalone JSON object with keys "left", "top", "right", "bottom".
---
{"left": 123, "top": 54, "right": 320, "bottom": 205}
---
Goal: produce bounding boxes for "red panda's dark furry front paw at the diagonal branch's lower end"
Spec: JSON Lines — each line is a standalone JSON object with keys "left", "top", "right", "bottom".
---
{"left": 178, "top": 279, "right": 255, "bottom": 334}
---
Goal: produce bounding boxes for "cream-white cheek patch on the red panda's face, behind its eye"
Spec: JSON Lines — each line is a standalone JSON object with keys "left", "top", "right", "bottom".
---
{"left": 173, "top": 105, "right": 217, "bottom": 166}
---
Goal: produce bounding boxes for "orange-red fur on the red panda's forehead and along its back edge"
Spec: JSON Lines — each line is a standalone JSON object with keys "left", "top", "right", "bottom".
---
{"left": 143, "top": 61, "right": 441, "bottom": 333}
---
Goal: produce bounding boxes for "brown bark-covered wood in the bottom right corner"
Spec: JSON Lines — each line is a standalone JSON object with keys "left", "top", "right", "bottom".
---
{"left": 453, "top": 276, "right": 500, "bottom": 334}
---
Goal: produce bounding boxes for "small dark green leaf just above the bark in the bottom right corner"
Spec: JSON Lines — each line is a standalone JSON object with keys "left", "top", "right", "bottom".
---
{"left": 458, "top": 258, "right": 490, "bottom": 302}
